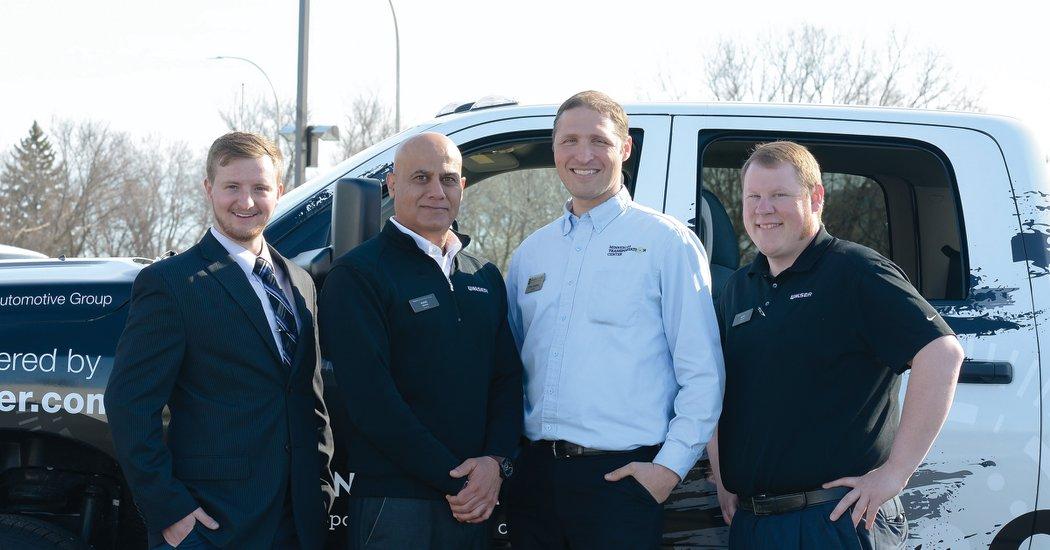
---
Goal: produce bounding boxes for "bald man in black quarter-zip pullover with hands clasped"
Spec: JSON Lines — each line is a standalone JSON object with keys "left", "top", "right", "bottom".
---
{"left": 319, "top": 133, "right": 523, "bottom": 550}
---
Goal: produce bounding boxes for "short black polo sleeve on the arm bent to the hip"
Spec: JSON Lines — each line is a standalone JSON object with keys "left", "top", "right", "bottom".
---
{"left": 857, "top": 259, "right": 954, "bottom": 374}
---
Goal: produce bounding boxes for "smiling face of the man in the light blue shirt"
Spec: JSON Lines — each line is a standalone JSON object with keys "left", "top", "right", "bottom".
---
{"left": 554, "top": 107, "right": 631, "bottom": 216}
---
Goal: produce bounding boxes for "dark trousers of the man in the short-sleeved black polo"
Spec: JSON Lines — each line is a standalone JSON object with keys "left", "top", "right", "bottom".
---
{"left": 729, "top": 496, "right": 908, "bottom": 550}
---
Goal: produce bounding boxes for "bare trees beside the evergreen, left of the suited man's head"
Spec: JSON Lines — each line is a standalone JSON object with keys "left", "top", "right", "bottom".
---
{"left": 0, "top": 121, "right": 209, "bottom": 257}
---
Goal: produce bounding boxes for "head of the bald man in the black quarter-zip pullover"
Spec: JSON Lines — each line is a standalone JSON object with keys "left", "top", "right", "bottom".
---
{"left": 386, "top": 132, "right": 466, "bottom": 248}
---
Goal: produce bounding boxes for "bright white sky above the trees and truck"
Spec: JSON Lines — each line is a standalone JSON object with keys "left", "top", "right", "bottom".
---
{"left": 0, "top": 0, "right": 1050, "bottom": 158}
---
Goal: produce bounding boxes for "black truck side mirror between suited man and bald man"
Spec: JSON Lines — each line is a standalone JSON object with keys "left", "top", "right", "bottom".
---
{"left": 292, "top": 177, "right": 382, "bottom": 288}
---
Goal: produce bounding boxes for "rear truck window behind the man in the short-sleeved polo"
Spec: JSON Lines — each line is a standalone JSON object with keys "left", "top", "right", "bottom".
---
{"left": 697, "top": 130, "right": 968, "bottom": 300}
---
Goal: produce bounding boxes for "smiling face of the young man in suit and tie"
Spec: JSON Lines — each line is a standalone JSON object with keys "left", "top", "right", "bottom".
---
{"left": 204, "top": 156, "right": 285, "bottom": 254}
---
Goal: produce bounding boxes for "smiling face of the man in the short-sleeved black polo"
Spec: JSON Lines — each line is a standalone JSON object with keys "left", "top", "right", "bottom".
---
{"left": 743, "top": 163, "right": 824, "bottom": 275}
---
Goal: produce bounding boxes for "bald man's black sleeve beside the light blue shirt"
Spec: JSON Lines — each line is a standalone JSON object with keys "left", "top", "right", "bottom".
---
{"left": 485, "top": 266, "right": 525, "bottom": 458}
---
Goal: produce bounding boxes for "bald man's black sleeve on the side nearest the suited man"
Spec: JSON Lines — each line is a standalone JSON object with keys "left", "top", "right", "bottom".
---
{"left": 318, "top": 261, "right": 463, "bottom": 494}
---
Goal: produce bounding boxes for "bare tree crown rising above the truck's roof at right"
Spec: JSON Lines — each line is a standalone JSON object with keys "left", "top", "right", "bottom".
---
{"left": 653, "top": 25, "right": 981, "bottom": 110}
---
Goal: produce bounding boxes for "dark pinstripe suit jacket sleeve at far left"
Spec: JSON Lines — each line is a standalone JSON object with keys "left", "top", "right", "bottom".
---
{"left": 104, "top": 268, "right": 197, "bottom": 531}
